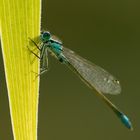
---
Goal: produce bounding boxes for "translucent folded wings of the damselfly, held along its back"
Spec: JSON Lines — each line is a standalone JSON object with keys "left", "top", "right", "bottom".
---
{"left": 63, "top": 48, "right": 121, "bottom": 95}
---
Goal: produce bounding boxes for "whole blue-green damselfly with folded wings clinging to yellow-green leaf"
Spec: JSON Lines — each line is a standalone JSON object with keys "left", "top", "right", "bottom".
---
{"left": 30, "top": 31, "right": 133, "bottom": 130}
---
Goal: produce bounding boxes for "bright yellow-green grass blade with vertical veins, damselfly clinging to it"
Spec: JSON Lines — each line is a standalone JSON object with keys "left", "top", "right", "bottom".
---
{"left": 0, "top": 0, "right": 41, "bottom": 140}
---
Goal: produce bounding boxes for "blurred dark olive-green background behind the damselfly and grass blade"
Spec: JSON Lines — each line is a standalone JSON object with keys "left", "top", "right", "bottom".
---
{"left": 0, "top": 0, "right": 140, "bottom": 140}
